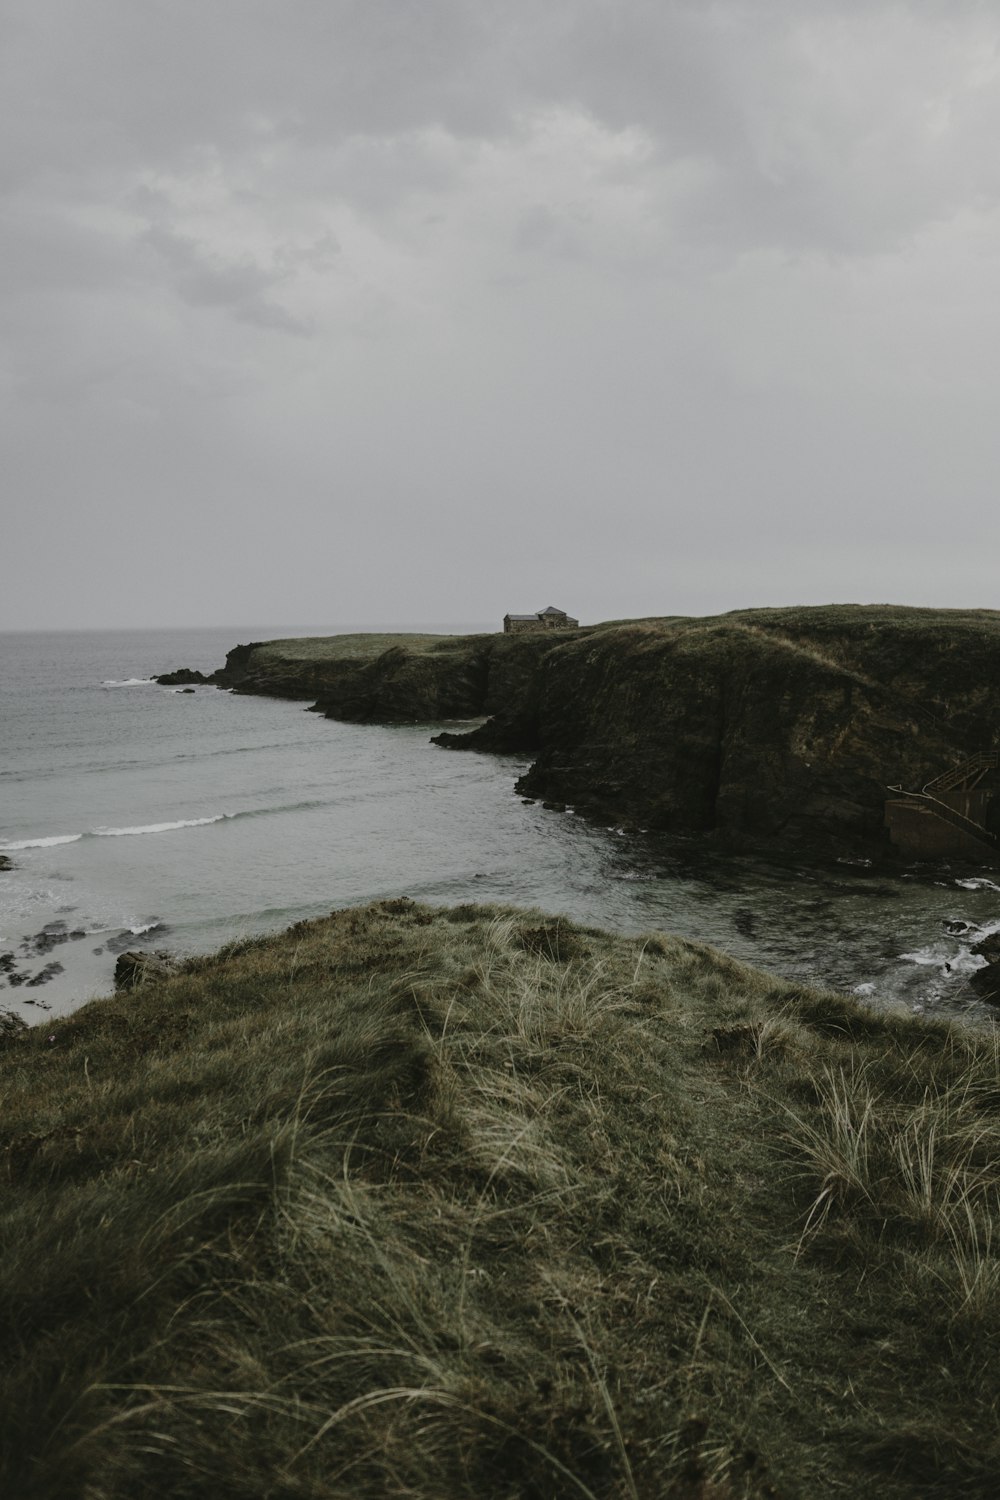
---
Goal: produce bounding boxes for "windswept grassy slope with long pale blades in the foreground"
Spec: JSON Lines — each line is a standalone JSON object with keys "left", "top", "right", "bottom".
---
{"left": 0, "top": 900, "right": 1000, "bottom": 1500}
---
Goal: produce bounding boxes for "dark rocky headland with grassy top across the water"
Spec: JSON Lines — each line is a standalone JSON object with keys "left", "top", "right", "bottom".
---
{"left": 166, "top": 605, "right": 1000, "bottom": 854}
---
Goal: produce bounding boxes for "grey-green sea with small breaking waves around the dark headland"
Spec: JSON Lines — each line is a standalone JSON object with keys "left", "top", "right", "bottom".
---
{"left": 0, "top": 623, "right": 1000, "bottom": 1025}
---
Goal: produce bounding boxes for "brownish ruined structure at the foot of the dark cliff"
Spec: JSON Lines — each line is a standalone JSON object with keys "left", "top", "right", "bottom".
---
{"left": 885, "top": 750, "right": 1000, "bottom": 860}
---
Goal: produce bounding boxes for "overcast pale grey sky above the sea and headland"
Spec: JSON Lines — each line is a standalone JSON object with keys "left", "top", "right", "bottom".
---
{"left": 0, "top": 0, "right": 1000, "bottom": 629}
